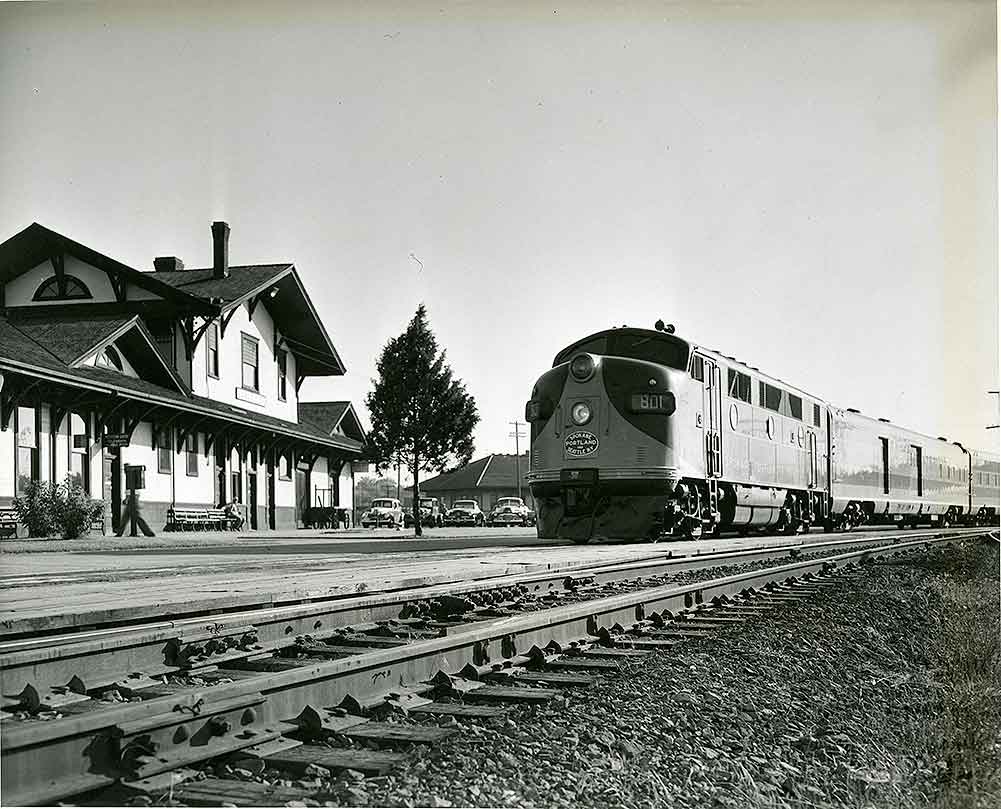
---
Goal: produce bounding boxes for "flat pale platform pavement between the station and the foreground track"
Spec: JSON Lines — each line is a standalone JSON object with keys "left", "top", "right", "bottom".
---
{"left": 0, "top": 529, "right": 888, "bottom": 637}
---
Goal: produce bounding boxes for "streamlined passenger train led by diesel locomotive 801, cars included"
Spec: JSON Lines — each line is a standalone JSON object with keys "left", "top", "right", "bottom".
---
{"left": 525, "top": 321, "right": 1001, "bottom": 543}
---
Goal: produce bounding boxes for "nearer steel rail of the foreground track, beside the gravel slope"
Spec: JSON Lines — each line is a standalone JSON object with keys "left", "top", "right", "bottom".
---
{"left": 0, "top": 531, "right": 987, "bottom": 804}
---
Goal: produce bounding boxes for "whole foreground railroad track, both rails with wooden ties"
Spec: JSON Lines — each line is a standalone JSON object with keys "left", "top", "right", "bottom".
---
{"left": 0, "top": 530, "right": 987, "bottom": 805}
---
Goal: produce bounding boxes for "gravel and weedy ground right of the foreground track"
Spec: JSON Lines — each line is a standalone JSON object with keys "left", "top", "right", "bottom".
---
{"left": 338, "top": 543, "right": 1001, "bottom": 809}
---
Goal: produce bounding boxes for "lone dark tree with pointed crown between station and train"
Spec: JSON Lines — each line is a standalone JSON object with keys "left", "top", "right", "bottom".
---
{"left": 365, "top": 303, "right": 479, "bottom": 537}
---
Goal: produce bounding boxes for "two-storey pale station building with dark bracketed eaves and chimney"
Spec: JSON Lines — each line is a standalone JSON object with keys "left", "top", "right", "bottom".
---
{"left": 0, "top": 222, "right": 365, "bottom": 533}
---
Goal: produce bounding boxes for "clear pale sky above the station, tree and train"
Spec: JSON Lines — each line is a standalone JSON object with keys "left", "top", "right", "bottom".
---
{"left": 0, "top": 0, "right": 999, "bottom": 474}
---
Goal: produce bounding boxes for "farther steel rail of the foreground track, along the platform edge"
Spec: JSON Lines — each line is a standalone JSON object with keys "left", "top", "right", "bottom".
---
{"left": 0, "top": 532, "right": 963, "bottom": 698}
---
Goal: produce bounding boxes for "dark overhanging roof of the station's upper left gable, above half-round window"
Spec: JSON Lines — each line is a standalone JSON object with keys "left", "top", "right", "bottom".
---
{"left": 0, "top": 222, "right": 218, "bottom": 314}
